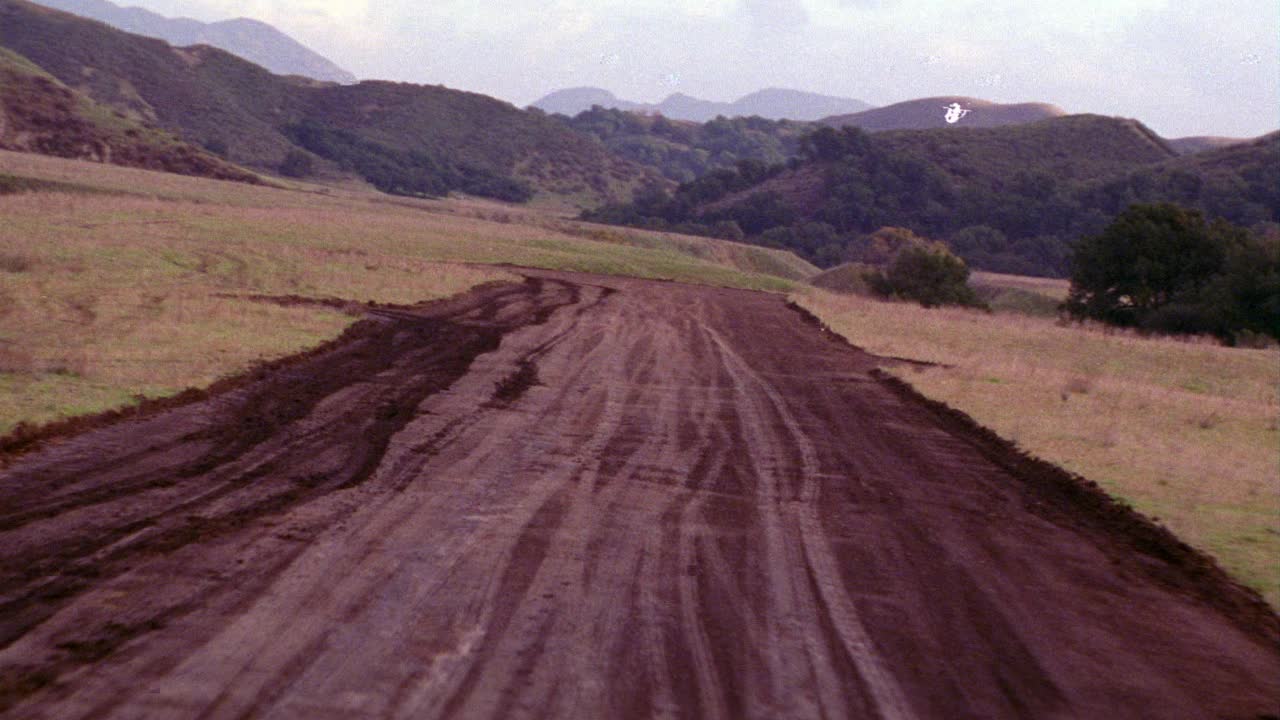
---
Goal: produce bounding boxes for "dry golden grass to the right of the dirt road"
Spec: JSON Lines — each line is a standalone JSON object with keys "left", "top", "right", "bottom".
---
{"left": 796, "top": 291, "right": 1280, "bottom": 605}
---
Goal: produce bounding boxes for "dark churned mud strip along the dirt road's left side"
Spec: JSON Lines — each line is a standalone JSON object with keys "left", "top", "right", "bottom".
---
{"left": 0, "top": 274, "right": 576, "bottom": 701}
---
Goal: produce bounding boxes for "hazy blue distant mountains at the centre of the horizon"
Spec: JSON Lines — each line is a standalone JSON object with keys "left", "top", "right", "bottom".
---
{"left": 532, "top": 87, "right": 873, "bottom": 123}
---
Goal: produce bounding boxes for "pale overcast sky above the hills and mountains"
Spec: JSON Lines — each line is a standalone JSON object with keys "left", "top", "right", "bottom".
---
{"left": 115, "top": 0, "right": 1280, "bottom": 137}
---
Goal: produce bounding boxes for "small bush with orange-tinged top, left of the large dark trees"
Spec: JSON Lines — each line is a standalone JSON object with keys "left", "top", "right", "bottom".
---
{"left": 867, "top": 243, "right": 982, "bottom": 307}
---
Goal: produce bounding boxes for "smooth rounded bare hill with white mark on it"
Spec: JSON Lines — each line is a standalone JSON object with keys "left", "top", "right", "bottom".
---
{"left": 822, "top": 95, "right": 1066, "bottom": 132}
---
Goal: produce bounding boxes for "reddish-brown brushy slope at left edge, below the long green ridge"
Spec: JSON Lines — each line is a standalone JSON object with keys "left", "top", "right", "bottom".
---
{"left": 0, "top": 47, "right": 259, "bottom": 183}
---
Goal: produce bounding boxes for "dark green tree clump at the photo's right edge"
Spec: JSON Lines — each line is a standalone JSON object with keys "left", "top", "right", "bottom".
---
{"left": 1065, "top": 202, "right": 1280, "bottom": 342}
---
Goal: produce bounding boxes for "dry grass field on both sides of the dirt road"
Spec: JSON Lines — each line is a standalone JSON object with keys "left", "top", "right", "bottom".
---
{"left": 0, "top": 146, "right": 1280, "bottom": 605}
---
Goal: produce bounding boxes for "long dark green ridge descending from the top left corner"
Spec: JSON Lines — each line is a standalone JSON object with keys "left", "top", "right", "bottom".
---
{"left": 0, "top": 0, "right": 655, "bottom": 205}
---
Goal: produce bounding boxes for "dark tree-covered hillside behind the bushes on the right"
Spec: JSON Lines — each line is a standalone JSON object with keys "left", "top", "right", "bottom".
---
{"left": 588, "top": 115, "right": 1280, "bottom": 277}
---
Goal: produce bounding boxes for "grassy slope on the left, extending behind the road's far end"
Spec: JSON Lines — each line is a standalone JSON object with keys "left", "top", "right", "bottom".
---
{"left": 0, "top": 152, "right": 810, "bottom": 433}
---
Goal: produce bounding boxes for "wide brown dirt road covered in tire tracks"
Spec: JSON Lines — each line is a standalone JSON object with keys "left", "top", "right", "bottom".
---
{"left": 0, "top": 273, "right": 1280, "bottom": 720}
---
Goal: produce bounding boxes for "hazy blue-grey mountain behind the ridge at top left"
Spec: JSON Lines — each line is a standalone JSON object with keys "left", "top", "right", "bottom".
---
{"left": 40, "top": 0, "right": 356, "bottom": 83}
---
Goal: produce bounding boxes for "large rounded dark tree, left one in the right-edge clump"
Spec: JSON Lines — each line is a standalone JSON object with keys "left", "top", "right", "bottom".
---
{"left": 1066, "top": 202, "right": 1230, "bottom": 325}
